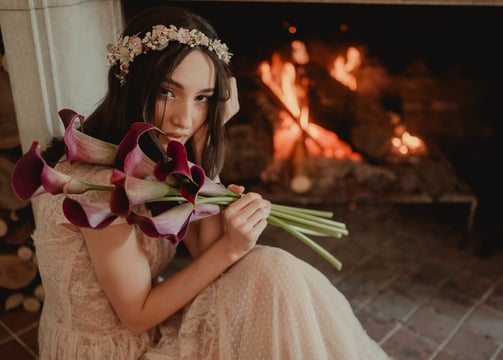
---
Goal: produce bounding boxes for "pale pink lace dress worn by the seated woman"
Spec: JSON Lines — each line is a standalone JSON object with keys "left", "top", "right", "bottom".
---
{"left": 34, "top": 162, "right": 388, "bottom": 360}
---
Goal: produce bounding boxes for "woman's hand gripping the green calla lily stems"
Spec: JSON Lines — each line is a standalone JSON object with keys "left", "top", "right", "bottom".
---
{"left": 220, "top": 191, "right": 271, "bottom": 258}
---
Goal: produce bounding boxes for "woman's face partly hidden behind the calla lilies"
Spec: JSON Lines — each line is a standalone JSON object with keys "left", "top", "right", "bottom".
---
{"left": 154, "top": 50, "right": 216, "bottom": 145}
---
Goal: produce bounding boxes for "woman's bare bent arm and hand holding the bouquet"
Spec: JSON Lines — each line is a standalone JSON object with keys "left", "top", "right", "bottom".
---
{"left": 82, "top": 193, "right": 270, "bottom": 332}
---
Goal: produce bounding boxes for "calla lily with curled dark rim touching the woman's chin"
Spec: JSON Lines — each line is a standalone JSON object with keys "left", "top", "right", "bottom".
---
{"left": 116, "top": 122, "right": 162, "bottom": 178}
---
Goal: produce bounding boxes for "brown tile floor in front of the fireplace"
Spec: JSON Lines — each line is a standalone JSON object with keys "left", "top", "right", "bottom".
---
{"left": 0, "top": 201, "right": 503, "bottom": 360}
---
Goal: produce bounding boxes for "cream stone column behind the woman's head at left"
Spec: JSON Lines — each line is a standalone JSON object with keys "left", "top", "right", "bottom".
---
{"left": 0, "top": 0, "right": 123, "bottom": 152}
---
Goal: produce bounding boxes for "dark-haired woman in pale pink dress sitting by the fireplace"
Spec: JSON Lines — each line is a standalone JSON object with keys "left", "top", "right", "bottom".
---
{"left": 34, "top": 5, "right": 387, "bottom": 360}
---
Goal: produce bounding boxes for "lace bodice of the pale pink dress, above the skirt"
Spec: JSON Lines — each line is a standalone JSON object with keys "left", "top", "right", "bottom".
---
{"left": 33, "top": 161, "right": 176, "bottom": 359}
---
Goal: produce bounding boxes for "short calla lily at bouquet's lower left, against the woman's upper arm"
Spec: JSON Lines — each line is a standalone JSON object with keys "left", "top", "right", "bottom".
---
{"left": 63, "top": 197, "right": 117, "bottom": 229}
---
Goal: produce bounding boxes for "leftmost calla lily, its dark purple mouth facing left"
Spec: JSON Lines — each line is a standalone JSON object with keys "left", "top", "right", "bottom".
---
{"left": 11, "top": 141, "right": 100, "bottom": 200}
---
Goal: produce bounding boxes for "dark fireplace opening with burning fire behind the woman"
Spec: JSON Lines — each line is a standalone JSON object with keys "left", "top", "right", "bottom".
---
{"left": 124, "top": 1, "right": 503, "bottom": 231}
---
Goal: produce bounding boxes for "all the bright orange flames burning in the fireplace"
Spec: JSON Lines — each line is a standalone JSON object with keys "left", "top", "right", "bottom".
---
{"left": 258, "top": 40, "right": 426, "bottom": 192}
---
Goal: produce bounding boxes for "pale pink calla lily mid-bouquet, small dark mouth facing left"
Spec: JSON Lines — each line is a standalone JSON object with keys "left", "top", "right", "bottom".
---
{"left": 110, "top": 169, "right": 180, "bottom": 217}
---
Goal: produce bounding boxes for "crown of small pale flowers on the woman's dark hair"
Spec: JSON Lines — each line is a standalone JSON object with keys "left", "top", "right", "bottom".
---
{"left": 107, "top": 25, "right": 232, "bottom": 85}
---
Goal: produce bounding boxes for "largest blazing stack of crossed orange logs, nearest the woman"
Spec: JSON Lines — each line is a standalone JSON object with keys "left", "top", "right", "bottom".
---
{"left": 258, "top": 48, "right": 361, "bottom": 193}
